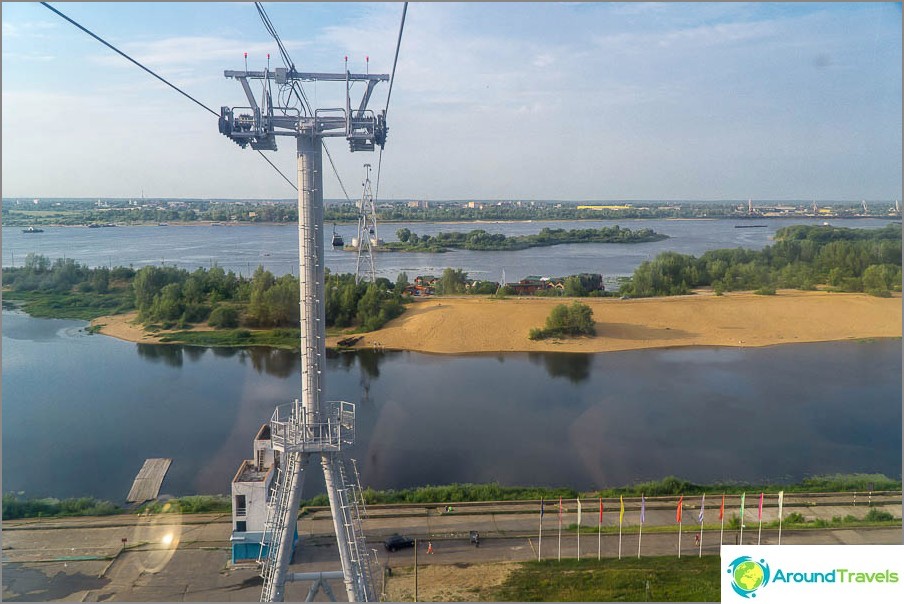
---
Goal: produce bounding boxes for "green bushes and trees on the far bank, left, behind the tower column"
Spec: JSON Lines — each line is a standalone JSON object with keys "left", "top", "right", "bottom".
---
{"left": 3, "top": 254, "right": 404, "bottom": 340}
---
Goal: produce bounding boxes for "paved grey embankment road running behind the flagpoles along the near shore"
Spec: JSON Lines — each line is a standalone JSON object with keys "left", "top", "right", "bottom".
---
{"left": 3, "top": 493, "right": 902, "bottom": 601}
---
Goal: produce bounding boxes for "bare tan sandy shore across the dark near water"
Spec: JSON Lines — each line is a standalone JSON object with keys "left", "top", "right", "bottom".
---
{"left": 92, "top": 290, "right": 902, "bottom": 354}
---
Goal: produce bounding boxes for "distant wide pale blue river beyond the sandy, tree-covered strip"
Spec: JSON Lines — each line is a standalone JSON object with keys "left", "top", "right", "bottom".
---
{"left": 2, "top": 218, "right": 889, "bottom": 281}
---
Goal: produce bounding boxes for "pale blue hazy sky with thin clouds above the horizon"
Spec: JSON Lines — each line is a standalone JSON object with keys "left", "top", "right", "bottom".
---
{"left": 0, "top": 2, "right": 902, "bottom": 201}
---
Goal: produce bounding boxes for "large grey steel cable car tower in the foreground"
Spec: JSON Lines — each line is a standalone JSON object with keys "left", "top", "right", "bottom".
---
{"left": 219, "top": 57, "right": 390, "bottom": 602}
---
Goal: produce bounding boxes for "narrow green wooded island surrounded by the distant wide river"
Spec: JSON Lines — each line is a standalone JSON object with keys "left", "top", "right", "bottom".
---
{"left": 380, "top": 225, "right": 668, "bottom": 252}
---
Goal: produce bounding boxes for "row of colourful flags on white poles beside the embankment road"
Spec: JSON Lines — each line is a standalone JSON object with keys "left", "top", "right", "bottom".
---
{"left": 537, "top": 491, "right": 785, "bottom": 560}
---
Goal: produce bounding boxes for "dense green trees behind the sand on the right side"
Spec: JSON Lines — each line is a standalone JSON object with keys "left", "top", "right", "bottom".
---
{"left": 621, "top": 223, "right": 901, "bottom": 297}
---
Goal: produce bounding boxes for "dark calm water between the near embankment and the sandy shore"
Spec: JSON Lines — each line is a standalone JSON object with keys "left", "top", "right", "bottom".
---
{"left": 2, "top": 310, "right": 902, "bottom": 501}
